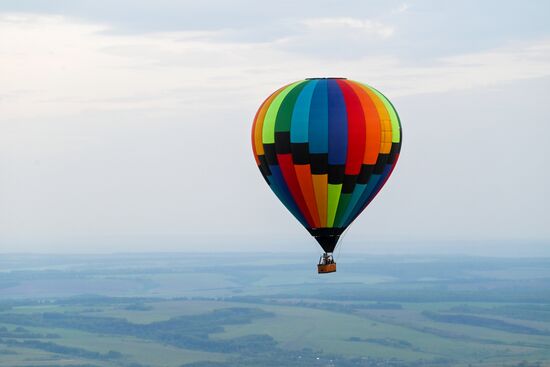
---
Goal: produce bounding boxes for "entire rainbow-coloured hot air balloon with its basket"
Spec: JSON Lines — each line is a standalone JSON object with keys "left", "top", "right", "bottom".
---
{"left": 252, "top": 78, "right": 401, "bottom": 273}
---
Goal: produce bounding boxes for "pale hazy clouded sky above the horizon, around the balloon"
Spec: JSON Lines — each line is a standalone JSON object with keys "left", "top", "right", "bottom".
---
{"left": 0, "top": 0, "right": 550, "bottom": 256}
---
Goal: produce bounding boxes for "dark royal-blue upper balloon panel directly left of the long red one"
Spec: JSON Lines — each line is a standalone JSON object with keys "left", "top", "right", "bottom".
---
{"left": 327, "top": 79, "right": 348, "bottom": 164}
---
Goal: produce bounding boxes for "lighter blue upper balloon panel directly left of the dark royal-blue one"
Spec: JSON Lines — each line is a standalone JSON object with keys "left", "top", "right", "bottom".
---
{"left": 309, "top": 79, "right": 328, "bottom": 153}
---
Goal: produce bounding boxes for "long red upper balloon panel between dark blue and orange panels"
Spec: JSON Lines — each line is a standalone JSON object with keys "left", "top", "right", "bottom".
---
{"left": 337, "top": 80, "right": 366, "bottom": 175}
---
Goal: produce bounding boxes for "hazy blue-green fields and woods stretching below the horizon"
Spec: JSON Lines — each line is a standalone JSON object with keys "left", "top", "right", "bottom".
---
{"left": 0, "top": 253, "right": 550, "bottom": 367}
